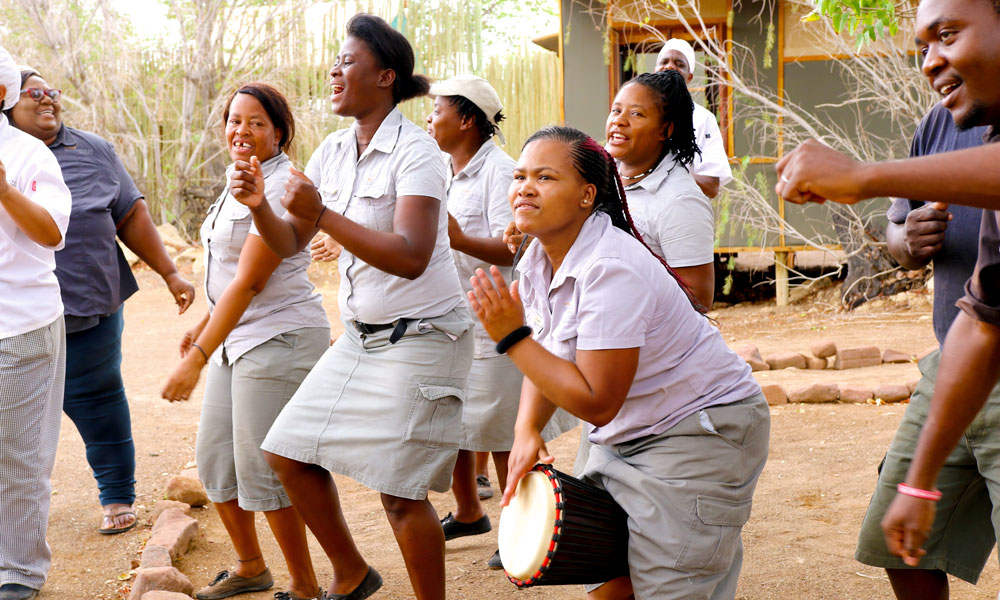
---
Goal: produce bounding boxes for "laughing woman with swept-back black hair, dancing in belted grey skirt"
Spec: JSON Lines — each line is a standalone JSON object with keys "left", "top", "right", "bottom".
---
{"left": 233, "top": 14, "right": 472, "bottom": 600}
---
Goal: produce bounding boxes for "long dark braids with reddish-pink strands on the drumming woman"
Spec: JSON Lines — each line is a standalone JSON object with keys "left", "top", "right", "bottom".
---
{"left": 524, "top": 125, "right": 707, "bottom": 313}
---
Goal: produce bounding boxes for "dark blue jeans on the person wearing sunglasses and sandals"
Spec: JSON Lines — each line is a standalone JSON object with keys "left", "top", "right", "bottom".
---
{"left": 63, "top": 308, "right": 135, "bottom": 506}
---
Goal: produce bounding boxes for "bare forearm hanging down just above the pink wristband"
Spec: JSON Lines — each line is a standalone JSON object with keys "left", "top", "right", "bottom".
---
{"left": 906, "top": 312, "right": 1000, "bottom": 490}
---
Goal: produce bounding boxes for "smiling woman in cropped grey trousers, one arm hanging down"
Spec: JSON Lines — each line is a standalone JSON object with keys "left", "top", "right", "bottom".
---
{"left": 162, "top": 82, "right": 330, "bottom": 600}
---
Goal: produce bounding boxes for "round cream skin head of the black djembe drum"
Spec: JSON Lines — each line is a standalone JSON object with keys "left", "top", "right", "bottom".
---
{"left": 497, "top": 471, "right": 556, "bottom": 579}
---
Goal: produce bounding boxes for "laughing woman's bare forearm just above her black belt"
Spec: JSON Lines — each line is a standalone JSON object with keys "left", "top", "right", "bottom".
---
{"left": 319, "top": 210, "right": 433, "bottom": 279}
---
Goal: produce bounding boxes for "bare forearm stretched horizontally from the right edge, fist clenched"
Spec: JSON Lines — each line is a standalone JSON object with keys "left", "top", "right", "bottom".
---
{"left": 858, "top": 144, "right": 1000, "bottom": 210}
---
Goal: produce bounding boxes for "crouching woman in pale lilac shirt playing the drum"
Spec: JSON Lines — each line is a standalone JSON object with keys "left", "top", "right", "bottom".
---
{"left": 469, "top": 127, "right": 770, "bottom": 599}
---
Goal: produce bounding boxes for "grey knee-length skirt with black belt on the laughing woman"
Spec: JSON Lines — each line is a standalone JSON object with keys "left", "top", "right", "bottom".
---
{"left": 261, "top": 308, "right": 473, "bottom": 500}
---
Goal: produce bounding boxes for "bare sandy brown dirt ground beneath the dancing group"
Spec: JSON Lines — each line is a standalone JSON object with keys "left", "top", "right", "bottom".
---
{"left": 40, "top": 267, "right": 1000, "bottom": 600}
